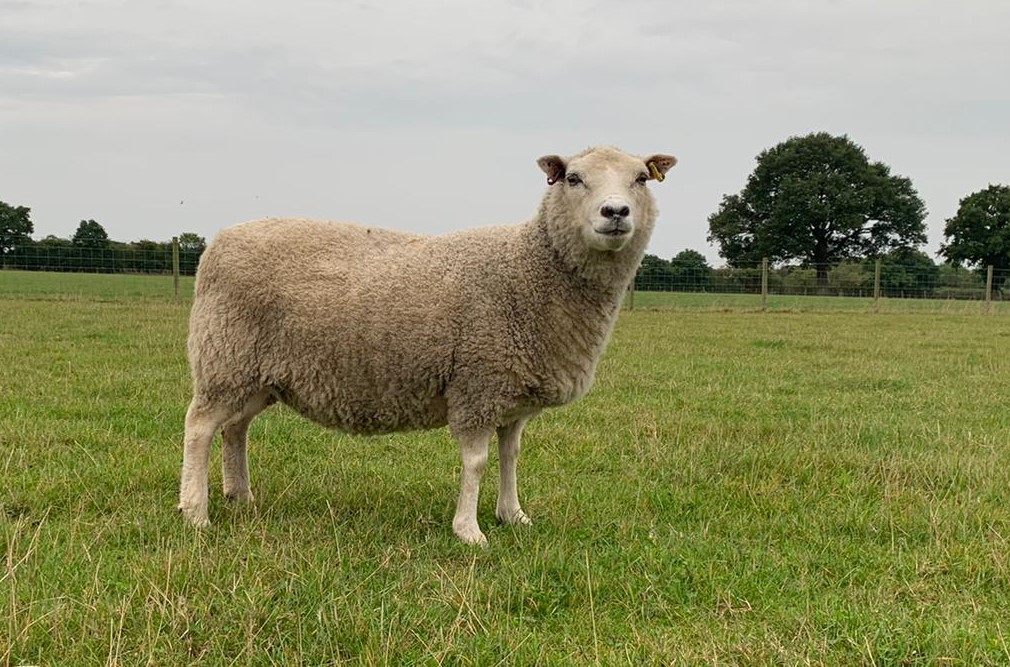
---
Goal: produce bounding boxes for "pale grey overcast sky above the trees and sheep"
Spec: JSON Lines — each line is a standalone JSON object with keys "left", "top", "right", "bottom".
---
{"left": 0, "top": 0, "right": 1010, "bottom": 265}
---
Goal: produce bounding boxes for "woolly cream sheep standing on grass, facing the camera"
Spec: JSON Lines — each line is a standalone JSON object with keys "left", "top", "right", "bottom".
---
{"left": 179, "top": 147, "right": 677, "bottom": 544}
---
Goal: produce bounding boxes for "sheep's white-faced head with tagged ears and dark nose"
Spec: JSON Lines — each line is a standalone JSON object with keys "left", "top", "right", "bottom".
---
{"left": 536, "top": 148, "right": 677, "bottom": 251}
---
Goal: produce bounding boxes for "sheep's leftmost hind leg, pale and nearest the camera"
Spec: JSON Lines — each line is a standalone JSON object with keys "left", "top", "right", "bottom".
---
{"left": 179, "top": 397, "right": 229, "bottom": 528}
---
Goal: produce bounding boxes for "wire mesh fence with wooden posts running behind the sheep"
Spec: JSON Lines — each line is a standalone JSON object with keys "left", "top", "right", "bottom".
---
{"left": 0, "top": 242, "right": 1010, "bottom": 311}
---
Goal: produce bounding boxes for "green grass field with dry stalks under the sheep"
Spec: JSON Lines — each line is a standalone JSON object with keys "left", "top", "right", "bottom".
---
{"left": 0, "top": 268, "right": 1010, "bottom": 666}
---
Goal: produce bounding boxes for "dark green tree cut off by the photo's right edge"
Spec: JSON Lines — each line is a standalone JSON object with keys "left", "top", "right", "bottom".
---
{"left": 940, "top": 185, "right": 1010, "bottom": 289}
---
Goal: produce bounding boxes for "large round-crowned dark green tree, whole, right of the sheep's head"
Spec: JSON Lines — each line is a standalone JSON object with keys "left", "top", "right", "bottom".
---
{"left": 708, "top": 132, "right": 926, "bottom": 287}
